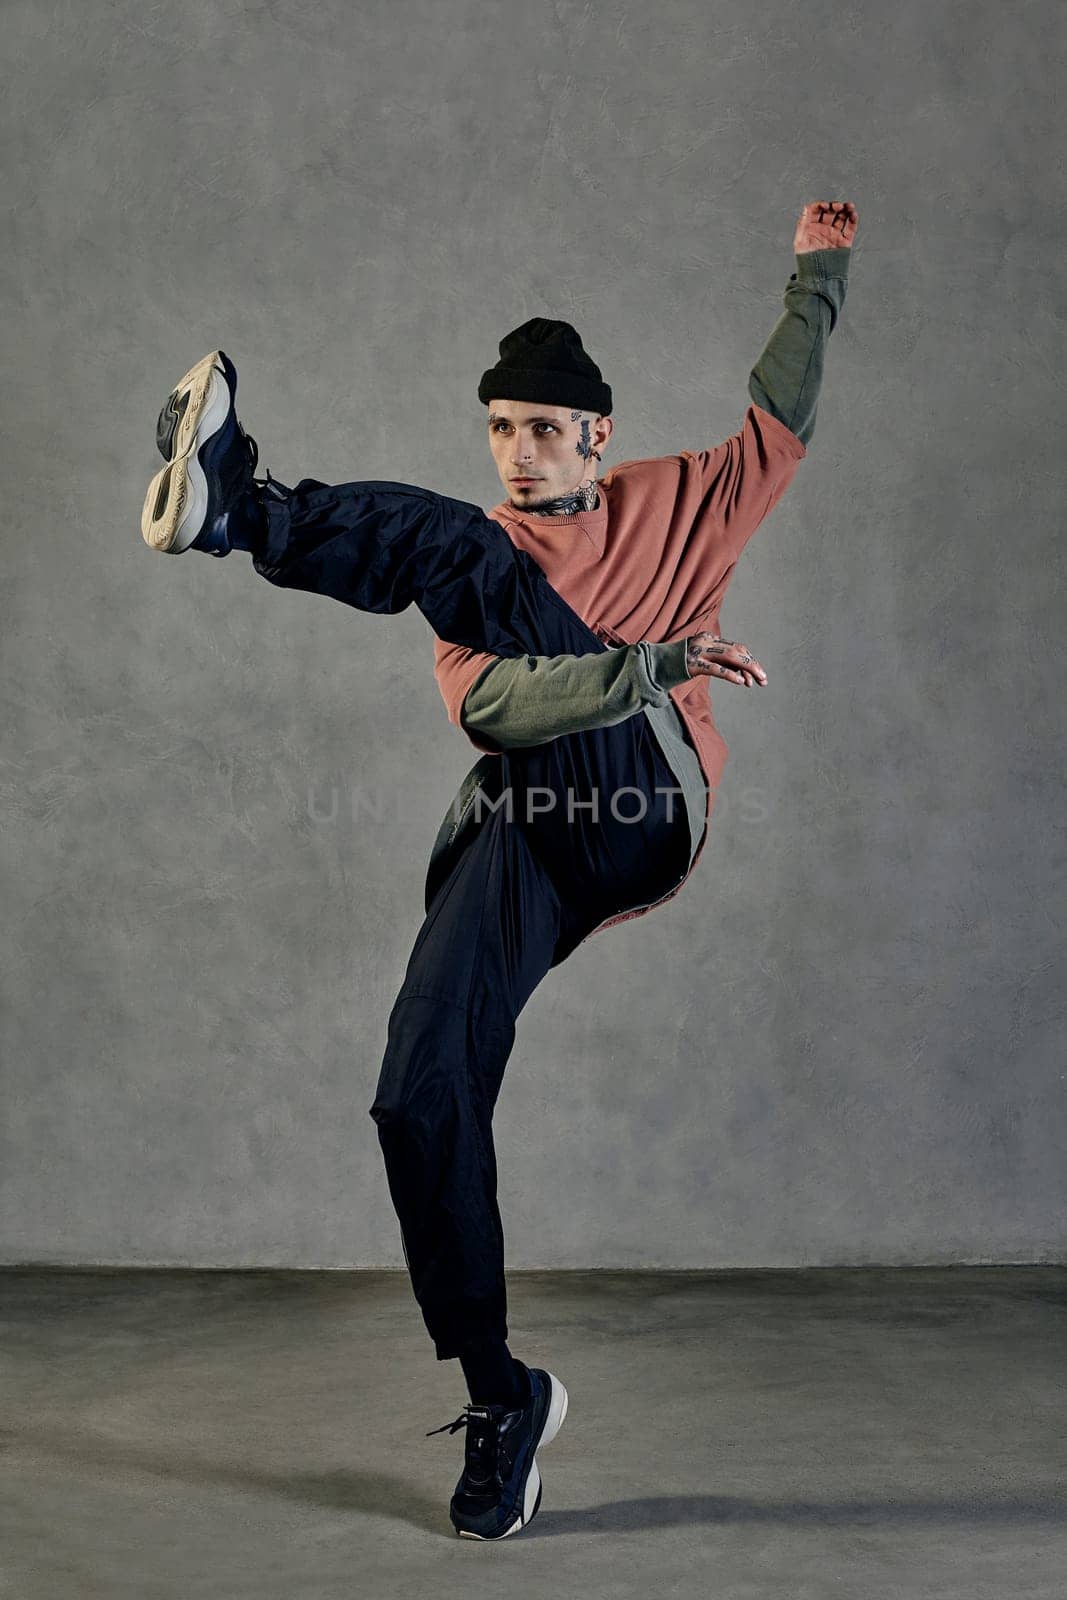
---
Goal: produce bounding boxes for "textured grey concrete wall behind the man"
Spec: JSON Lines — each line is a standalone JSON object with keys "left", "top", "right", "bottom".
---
{"left": 0, "top": 0, "right": 1067, "bottom": 1267}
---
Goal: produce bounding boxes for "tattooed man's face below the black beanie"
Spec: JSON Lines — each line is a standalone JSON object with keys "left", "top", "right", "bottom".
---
{"left": 486, "top": 400, "right": 613, "bottom": 510}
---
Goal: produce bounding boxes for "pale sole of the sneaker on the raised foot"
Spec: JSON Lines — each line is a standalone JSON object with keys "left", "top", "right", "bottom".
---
{"left": 141, "top": 350, "right": 235, "bottom": 555}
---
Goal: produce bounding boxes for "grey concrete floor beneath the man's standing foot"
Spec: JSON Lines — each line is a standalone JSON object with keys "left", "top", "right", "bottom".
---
{"left": 0, "top": 1267, "right": 1067, "bottom": 1600}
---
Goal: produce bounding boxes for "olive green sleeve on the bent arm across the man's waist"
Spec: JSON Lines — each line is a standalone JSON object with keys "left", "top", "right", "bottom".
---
{"left": 459, "top": 638, "right": 689, "bottom": 750}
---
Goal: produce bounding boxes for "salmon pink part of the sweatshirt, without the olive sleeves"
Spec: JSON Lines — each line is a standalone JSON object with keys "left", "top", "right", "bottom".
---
{"left": 434, "top": 405, "right": 808, "bottom": 926}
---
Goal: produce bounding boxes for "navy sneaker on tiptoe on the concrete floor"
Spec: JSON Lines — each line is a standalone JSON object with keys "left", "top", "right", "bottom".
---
{"left": 426, "top": 1362, "right": 566, "bottom": 1539}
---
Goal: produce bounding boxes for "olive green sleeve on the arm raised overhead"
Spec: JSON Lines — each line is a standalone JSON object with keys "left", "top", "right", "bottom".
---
{"left": 749, "top": 245, "right": 853, "bottom": 445}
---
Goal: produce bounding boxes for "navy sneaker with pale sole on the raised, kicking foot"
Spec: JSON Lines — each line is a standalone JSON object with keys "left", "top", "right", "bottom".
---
{"left": 141, "top": 350, "right": 270, "bottom": 555}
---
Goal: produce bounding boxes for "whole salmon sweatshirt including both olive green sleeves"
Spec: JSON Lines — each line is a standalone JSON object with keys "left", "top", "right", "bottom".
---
{"left": 434, "top": 248, "right": 851, "bottom": 931}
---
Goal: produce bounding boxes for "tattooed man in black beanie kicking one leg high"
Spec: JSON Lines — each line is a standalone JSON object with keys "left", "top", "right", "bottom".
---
{"left": 141, "top": 202, "right": 857, "bottom": 1539}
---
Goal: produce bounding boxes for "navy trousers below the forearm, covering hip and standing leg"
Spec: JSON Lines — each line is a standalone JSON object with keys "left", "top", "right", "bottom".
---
{"left": 370, "top": 688, "right": 689, "bottom": 1360}
